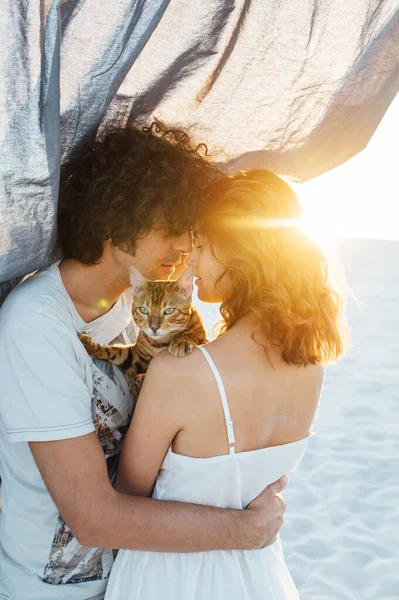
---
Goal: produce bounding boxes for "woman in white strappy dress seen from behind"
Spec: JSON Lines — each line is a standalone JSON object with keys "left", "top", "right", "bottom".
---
{"left": 106, "top": 170, "right": 342, "bottom": 600}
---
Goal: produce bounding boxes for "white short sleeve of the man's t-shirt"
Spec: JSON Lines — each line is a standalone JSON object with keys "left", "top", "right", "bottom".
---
{"left": 0, "top": 323, "right": 94, "bottom": 442}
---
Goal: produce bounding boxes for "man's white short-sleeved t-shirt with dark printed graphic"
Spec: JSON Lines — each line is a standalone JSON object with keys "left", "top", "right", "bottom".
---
{"left": 0, "top": 262, "right": 136, "bottom": 600}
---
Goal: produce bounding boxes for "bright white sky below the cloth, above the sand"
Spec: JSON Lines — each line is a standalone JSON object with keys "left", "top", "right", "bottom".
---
{"left": 294, "top": 94, "right": 399, "bottom": 241}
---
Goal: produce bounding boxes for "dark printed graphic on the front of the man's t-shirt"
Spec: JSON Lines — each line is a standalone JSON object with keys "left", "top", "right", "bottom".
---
{"left": 43, "top": 328, "right": 134, "bottom": 585}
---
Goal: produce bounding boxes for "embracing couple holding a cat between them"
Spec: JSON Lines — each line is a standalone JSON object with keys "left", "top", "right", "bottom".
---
{"left": 0, "top": 126, "right": 343, "bottom": 600}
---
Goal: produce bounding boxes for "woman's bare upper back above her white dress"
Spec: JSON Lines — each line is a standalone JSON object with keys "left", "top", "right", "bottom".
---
{"left": 172, "top": 318, "right": 324, "bottom": 458}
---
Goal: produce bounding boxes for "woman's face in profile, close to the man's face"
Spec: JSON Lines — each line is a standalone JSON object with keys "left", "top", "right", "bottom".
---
{"left": 186, "top": 234, "right": 228, "bottom": 302}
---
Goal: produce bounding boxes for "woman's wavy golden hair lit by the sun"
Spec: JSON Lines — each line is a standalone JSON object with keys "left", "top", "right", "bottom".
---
{"left": 199, "top": 170, "right": 346, "bottom": 366}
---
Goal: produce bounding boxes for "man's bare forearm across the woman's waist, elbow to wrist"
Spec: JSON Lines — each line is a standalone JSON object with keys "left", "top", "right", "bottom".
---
{"left": 78, "top": 492, "right": 258, "bottom": 552}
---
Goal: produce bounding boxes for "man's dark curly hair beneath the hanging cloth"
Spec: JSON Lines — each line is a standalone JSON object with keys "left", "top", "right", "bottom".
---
{"left": 58, "top": 123, "right": 218, "bottom": 264}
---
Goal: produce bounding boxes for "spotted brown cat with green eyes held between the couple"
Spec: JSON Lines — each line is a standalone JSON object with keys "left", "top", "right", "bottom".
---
{"left": 79, "top": 267, "right": 208, "bottom": 396}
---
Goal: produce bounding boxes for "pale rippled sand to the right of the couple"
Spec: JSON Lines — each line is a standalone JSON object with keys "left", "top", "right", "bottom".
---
{"left": 197, "top": 240, "right": 399, "bottom": 600}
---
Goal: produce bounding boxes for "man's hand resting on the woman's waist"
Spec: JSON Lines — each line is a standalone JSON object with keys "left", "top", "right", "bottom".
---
{"left": 247, "top": 475, "right": 289, "bottom": 548}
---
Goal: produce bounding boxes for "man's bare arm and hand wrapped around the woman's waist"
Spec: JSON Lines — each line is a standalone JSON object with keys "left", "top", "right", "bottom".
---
{"left": 29, "top": 432, "right": 286, "bottom": 552}
